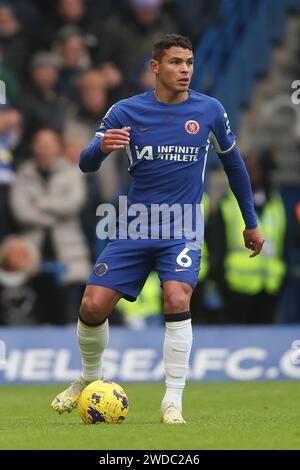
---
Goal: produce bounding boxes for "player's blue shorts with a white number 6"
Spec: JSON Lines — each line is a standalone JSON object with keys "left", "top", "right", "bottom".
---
{"left": 87, "top": 238, "right": 201, "bottom": 302}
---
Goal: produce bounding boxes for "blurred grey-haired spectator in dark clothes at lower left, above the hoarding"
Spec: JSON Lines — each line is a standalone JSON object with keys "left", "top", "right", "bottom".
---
{"left": 0, "top": 235, "right": 65, "bottom": 326}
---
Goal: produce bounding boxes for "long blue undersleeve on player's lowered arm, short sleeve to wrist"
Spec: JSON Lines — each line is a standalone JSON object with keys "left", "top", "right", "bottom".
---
{"left": 220, "top": 147, "right": 257, "bottom": 229}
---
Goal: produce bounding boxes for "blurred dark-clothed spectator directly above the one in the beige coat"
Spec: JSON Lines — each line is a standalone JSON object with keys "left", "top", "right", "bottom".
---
{"left": 19, "top": 52, "right": 66, "bottom": 152}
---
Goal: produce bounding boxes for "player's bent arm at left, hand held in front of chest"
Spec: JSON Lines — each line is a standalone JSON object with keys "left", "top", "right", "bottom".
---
{"left": 79, "top": 103, "right": 130, "bottom": 173}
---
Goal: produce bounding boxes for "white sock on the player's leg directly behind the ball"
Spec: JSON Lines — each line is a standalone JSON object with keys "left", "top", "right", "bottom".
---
{"left": 77, "top": 319, "right": 109, "bottom": 382}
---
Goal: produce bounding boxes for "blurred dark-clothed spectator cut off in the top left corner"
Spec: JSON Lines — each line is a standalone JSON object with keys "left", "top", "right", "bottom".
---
{"left": 0, "top": 2, "right": 31, "bottom": 82}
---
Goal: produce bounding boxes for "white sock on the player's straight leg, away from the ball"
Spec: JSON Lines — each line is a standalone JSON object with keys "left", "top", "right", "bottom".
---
{"left": 162, "top": 319, "right": 193, "bottom": 410}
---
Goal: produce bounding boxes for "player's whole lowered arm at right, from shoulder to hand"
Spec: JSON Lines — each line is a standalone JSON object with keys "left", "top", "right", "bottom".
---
{"left": 210, "top": 102, "right": 264, "bottom": 258}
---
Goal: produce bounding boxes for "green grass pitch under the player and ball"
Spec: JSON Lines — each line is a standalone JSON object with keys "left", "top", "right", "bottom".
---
{"left": 0, "top": 381, "right": 300, "bottom": 450}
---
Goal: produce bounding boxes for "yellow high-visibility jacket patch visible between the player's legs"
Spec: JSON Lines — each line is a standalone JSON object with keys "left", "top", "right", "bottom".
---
{"left": 118, "top": 271, "right": 162, "bottom": 318}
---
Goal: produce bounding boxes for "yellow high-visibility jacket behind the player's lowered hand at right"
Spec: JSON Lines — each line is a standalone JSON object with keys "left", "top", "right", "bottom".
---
{"left": 221, "top": 192, "right": 286, "bottom": 295}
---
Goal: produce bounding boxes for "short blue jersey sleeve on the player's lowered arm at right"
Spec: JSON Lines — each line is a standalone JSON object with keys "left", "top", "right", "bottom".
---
{"left": 209, "top": 101, "right": 236, "bottom": 155}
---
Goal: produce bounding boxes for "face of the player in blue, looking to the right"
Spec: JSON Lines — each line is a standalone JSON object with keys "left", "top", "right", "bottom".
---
{"left": 153, "top": 47, "right": 194, "bottom": 93}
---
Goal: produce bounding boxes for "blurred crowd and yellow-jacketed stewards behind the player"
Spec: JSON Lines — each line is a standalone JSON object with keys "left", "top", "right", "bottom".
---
{"left": 0, "top": 0, "right": 300, "bottom": 328}
